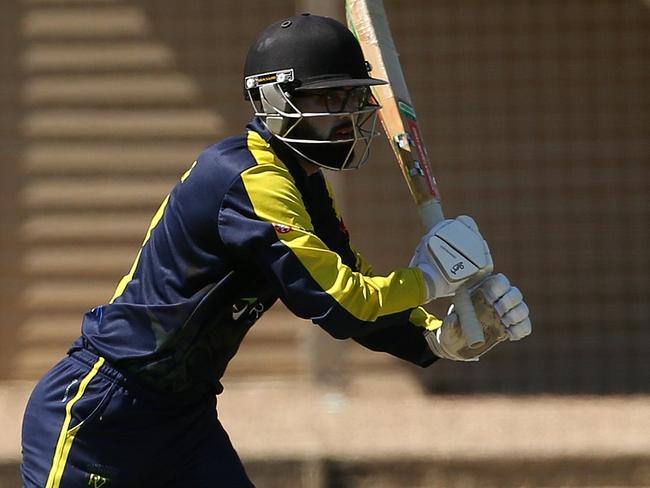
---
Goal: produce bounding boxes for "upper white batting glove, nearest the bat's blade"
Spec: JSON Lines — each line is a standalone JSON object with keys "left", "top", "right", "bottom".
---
{"left": 410, "top": 215, "right": 493, "bottom": 302}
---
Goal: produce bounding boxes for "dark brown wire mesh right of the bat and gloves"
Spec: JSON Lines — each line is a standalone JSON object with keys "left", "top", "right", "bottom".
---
{"left": 349, "top": 0, "right": 650, "bottom": 392}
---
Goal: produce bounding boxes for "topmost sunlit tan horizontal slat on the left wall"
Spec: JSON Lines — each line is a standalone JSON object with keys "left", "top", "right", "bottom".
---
{"left": 22, "top": 2, "right": 151, "bottom": 41}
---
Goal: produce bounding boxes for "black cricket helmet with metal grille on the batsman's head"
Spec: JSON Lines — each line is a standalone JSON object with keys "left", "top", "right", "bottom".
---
{"left": 244, "top": 14, "right": 386, "bottom": 170}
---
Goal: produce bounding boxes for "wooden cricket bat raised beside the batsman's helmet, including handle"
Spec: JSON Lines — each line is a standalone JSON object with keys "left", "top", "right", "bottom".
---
{"left": 345, "top": 0, "right": 485, "bottom": 348}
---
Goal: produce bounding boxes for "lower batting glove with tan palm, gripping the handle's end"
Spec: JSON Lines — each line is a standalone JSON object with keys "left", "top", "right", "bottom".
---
{"left": 425, "top": 273, "right": 532, "bottom": 361}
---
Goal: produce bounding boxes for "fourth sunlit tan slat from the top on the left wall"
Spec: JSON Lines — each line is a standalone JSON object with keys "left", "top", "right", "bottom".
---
{"left": 23, "top": 108, "right": 223, "bottom": 141}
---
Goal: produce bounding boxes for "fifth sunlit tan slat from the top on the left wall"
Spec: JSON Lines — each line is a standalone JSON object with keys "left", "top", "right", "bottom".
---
{"left": 24, "top": 141, "right": 197, "bottom": 177}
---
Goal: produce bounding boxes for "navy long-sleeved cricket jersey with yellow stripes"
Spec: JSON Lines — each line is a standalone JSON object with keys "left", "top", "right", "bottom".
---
{"left": 79, "top": 120, "right": 440, "bottom": 397}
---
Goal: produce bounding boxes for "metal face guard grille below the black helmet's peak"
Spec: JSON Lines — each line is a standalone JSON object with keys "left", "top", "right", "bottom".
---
{"left": 247, "top": 78, "right": 380, "bottom": 170}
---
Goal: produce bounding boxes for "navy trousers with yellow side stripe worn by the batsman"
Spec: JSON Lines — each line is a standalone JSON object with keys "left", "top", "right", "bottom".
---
{"left": 21, "top": 349, "right": 253, "bottom": 488}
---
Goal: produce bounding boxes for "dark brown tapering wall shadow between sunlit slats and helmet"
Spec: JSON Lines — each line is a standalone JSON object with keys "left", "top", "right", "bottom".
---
{"left": 138, "top": 0, "right": 295, "bottom": 135}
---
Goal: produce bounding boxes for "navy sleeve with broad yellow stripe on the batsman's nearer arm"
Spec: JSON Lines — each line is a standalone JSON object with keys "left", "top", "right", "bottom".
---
{"left": 218, "top": 160, "right": 426, "bottom": 338}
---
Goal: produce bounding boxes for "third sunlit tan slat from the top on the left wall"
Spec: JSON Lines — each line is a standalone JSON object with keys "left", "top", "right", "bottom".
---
{"left": 22, "top": 73, "right": 200, "bottom": 108}
